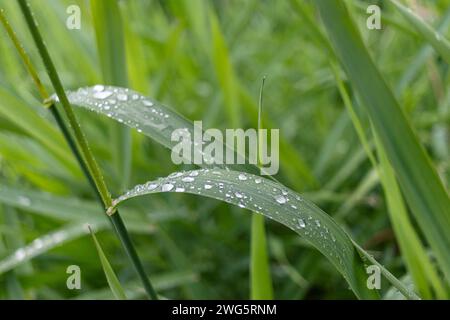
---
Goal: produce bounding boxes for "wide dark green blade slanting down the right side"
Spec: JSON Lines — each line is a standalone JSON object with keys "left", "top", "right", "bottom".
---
{"left": 315, "top": 0, "right": 450, "bottom": 281}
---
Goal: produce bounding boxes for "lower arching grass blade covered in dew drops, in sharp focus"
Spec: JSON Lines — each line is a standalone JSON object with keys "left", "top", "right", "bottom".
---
{"left": 109, "top": 169, "right": 413, "bottom": 299}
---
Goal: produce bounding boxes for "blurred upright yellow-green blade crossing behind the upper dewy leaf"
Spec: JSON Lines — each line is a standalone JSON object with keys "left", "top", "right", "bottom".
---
{"left": 91, "top": 0, "right": 132, "bottom": 189}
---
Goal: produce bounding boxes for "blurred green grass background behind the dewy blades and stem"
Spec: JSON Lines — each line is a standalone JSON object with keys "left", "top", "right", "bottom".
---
{"left": 0, "top": 0, "right": 450, "bottom": 299}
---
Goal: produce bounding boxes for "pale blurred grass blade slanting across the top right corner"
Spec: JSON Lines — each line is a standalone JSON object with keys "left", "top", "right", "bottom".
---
{"left": 390, "top": 0, "right": 450, "bottom": 64}
